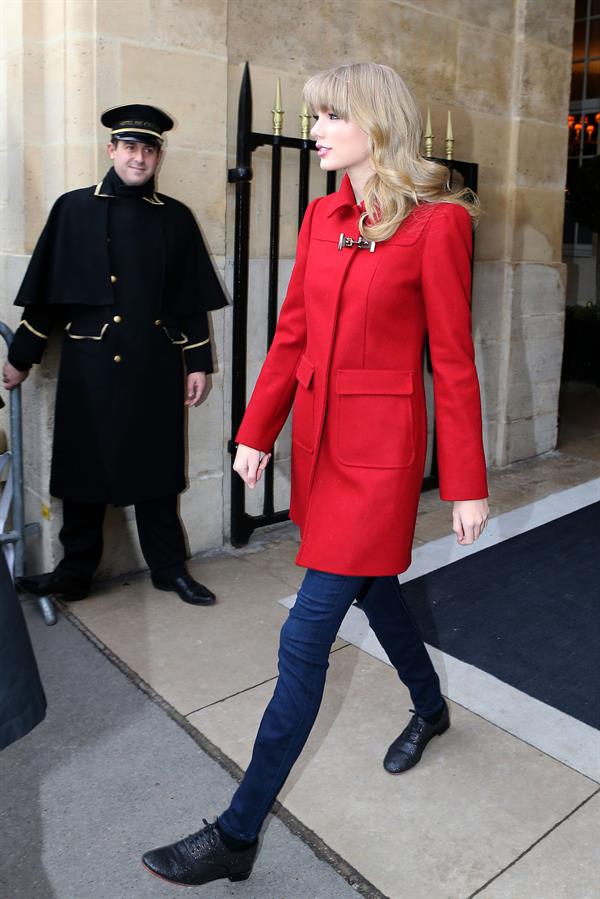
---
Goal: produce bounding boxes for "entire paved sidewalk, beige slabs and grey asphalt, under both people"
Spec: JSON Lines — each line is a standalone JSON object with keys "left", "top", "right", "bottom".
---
{"left": 0, "top": 435, "right": 600, "bottom": 899}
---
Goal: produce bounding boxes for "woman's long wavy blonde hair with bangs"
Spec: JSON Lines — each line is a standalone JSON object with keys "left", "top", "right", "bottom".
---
{"left": 303, "top": 63, "right": 479, "bottom": 241}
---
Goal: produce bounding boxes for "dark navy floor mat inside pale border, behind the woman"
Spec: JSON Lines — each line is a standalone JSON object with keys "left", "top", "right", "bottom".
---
{"left": 403, "top": 503, "right": 600, "bottom": 729}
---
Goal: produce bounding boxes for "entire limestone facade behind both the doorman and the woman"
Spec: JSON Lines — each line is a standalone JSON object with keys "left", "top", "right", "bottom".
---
{"left": 0, "top": 0, "right": 573, "bottom": 576}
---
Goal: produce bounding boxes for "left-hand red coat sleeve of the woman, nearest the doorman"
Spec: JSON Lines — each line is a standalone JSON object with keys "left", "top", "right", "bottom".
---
{"left": 235, "top": 200, "right": 319, "bottom": 452}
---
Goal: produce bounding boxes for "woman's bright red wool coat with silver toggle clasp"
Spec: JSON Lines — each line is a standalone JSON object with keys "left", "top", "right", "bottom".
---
{"left": 236, "top": 176, "right": 487, "bottom": 575}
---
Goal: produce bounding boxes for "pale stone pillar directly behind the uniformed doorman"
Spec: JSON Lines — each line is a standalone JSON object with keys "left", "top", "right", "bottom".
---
{"left": 0, "top": 0, "right": 227, "bottom": 577}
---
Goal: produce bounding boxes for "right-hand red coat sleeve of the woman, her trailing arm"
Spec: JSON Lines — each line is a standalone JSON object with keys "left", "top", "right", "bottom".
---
{"left": 422, "top": 203, "right": 488, "bottom": 500}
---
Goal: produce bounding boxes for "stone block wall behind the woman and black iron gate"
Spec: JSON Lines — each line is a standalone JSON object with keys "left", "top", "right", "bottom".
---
{"left": 228, "top": 0, "right": 573, "bottom": 478}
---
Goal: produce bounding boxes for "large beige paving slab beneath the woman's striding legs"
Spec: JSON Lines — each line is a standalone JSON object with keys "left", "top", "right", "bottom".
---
{"left": 190, "top": 647, "right": 597, "bottom": 899}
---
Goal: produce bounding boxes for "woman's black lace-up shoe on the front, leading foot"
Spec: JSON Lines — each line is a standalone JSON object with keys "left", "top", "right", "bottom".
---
{"left": 142, "top": 818, "right": 258, "bottom": 886}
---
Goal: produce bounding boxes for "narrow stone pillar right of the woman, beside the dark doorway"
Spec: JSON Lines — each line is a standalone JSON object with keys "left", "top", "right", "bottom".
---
{"left": 495, "top": 0, "right": 573, "bottom": 465}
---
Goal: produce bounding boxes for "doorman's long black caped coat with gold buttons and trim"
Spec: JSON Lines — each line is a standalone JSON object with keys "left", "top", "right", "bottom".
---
{"left": 9, "top": 170, "right": 226, "bottom": 505}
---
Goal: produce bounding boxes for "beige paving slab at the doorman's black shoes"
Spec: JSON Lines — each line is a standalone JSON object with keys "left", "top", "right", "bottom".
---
{"left": 69, "top": 555, "right": 342, "bottom": 715}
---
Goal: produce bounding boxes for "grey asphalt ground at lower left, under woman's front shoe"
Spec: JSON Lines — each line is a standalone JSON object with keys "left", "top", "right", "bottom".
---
{"left": 0, "top": 603, "right": 370, "bottom": 899}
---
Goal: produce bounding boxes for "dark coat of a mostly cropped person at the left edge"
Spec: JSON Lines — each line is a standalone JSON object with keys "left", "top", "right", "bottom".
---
{"left": 0, "top": 549, "right": 46, "bottom": 749}
